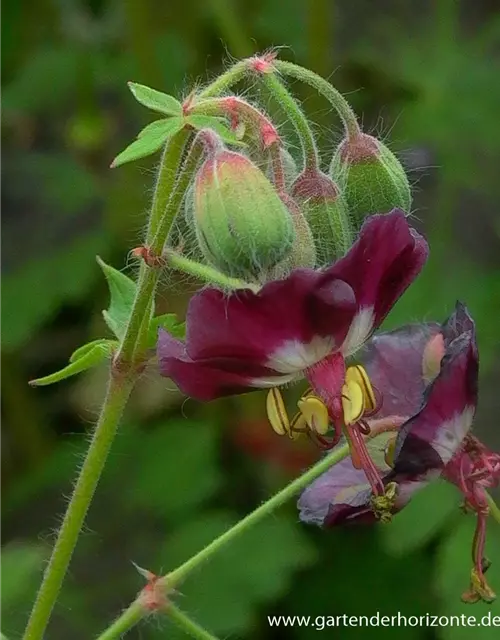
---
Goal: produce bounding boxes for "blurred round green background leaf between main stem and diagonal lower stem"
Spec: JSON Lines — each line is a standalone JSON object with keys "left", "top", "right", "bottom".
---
{"left": 123, "top": 422, "right": 222, "bottom": 518}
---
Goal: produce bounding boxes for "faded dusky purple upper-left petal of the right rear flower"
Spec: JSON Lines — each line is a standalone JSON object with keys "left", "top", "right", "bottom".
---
{"left": 356, "top": 323, "right": 440, "bottom": 418}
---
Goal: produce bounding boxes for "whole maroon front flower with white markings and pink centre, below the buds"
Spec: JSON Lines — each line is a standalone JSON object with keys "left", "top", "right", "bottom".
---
{"left": 158, "top": 210, "right": 428, "bottom": 400}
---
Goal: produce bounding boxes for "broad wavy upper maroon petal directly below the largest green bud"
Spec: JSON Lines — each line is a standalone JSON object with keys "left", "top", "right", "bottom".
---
{"left": 186, "top": 269, "right": 356, "bottom": 364}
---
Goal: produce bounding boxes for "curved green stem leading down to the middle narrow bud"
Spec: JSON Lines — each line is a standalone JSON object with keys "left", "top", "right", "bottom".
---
{"left": 260, "top": 73, "right": 319, "bottom": 169}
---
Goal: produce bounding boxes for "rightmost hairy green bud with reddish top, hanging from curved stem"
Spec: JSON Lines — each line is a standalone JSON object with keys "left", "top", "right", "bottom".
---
{"left": 331, "top": 133, "right": 411, "bottom": 225}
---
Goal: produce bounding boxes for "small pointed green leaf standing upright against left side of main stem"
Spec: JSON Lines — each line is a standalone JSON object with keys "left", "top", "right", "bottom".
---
{"left": 97, "top": 256, "right": 137, "bottom": 340}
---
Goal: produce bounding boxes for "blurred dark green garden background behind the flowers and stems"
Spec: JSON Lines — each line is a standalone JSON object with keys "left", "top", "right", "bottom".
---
{"left": 0, "top": 0, "right": 500, "bottom": 640}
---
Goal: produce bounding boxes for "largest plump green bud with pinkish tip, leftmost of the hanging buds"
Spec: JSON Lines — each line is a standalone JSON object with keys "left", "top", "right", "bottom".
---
{"left": 194, "top": 151, "right": 295, "bottom": 278}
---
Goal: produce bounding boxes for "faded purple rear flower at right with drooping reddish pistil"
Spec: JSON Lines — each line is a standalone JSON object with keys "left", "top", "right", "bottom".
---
{"left": 298, "top": 303, "right": 500, "bottom": 602}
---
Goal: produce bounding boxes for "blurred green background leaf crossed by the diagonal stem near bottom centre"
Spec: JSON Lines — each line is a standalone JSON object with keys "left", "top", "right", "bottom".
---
{"left": 160, "top": 511, "right": 316, "bottom": 640}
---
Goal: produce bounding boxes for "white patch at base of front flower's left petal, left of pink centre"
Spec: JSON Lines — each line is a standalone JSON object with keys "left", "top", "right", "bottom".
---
{"left": 266, "top": 336, "right": 335, "bottom": 374}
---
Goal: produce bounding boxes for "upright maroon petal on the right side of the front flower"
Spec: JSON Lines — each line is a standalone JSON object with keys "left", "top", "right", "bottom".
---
{"left": 327, "top": 209, "right": 429, "bottom": 340}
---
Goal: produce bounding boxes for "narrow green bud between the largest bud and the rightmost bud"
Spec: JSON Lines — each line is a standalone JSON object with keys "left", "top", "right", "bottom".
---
{"left": 291, "top": 168, "right": 352, "bottom": 265}
